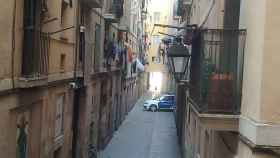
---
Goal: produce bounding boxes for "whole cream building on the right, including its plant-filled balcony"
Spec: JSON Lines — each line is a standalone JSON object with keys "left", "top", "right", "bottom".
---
{"left": 177, "top": 0, "right": 280, "bottom": 158}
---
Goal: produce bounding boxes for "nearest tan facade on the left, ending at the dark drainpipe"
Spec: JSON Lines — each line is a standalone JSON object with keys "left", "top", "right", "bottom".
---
{"left": 0, "top": 0, "right": 76, "bottom": 158}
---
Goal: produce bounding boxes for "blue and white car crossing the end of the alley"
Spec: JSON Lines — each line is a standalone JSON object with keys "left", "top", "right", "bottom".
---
{"left": 144, "top": 94, "right": 175, "bottom": 112}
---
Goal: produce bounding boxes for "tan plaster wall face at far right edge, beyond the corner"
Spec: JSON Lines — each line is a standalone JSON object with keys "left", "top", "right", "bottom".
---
{"left": 260, "top": 1, "right": 280, "bottom": 125}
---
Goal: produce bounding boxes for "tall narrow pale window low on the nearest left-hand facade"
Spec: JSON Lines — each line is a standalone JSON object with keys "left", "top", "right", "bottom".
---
{"left": 55, "top": 94, "right": 65, "bottom": 137}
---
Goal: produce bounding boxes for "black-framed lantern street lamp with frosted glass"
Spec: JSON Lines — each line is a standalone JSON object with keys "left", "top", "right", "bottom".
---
{"left": 167, "top": 37, "right": 191, "bottom": 82}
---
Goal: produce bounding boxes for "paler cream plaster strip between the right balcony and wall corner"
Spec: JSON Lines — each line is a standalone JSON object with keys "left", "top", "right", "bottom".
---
{"left": 240, "top": 0, "right": 266, "bottom": 121}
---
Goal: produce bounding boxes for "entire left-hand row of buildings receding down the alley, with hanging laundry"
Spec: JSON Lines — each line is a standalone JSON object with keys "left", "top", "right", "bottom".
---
{"left": 0, "top": 0, "right": 146, "bottom": 158}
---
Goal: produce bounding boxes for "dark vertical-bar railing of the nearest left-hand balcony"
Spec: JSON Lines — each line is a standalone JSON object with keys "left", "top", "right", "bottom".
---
{"left": 22, "top": 31, "right": 50, "bottom": 78}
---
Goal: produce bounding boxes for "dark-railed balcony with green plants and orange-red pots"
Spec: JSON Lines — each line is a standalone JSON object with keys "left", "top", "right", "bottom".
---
{"left": 189, "top": 29, "right": 246, "bottom": 115}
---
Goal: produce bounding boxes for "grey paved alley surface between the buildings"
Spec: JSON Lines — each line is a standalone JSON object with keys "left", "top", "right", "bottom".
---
{"left": 99, "top": 95, "right": 180, "bottom": 158}
